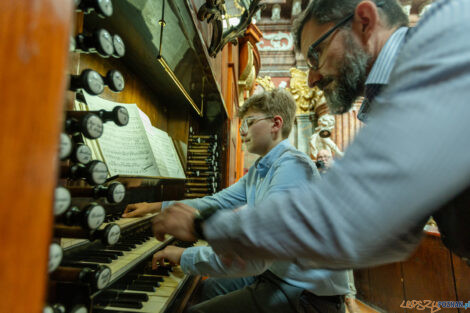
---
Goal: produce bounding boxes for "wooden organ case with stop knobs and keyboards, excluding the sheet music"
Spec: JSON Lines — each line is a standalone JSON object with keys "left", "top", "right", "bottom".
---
{"left": 0, "top": 0, "right": 248, "bottom": 313}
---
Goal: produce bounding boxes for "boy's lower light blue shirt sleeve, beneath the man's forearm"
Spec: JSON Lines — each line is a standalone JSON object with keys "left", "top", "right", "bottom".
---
{"left": 180, "top": 247, "right": 271, "bottom": 277}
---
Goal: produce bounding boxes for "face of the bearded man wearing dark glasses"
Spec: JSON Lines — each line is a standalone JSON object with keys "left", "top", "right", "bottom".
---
{"left": 301, "top": 20, "right": 372, "bottom": 114}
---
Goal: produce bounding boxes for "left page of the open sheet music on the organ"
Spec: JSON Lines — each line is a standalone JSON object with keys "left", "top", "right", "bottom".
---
{"left": 84, "top": 93, "right": 162, "bottom": 176}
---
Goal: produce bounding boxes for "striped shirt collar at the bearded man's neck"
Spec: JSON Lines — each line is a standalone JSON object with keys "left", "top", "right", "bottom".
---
{"left": 365, "top": 27, "right": 408, "bottom": 85}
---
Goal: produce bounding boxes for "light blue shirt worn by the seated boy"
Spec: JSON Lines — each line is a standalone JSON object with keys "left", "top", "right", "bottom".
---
{"left": 165, "top": 139, "right": 349, "bottom": 296}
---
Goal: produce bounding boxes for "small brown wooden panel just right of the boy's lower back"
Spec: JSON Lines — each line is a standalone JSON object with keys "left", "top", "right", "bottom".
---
{"left": 369, "top": 263, "right": 405, "bottom": 312}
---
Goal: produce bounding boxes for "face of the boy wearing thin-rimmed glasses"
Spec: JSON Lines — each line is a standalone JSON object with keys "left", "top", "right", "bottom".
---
{"left": 240, "top": 109, "right": 274, "bottom": 156}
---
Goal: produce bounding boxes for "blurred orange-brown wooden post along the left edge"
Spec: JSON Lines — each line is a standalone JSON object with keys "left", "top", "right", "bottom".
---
{"left": 0, "top": 0, "right": 72, "bottom": 313}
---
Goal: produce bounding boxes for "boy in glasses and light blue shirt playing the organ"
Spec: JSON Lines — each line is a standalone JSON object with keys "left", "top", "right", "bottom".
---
{"left": 124, "top": 89, "right": 349, "bottom": 313}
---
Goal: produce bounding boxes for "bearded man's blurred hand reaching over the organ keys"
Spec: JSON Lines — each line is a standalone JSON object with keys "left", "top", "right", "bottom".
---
{"left": 152, "top": 202, "right": 197, "bottom": 241}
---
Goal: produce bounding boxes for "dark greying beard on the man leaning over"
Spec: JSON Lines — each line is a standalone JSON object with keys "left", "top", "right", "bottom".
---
{"left": 317, "top": 32, "right": 372, "bottom": 114}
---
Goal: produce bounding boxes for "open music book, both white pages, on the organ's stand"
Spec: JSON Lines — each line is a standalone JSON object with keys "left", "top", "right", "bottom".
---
{"left": 75, "top": 93, "right": 185, "bottom": 178}
